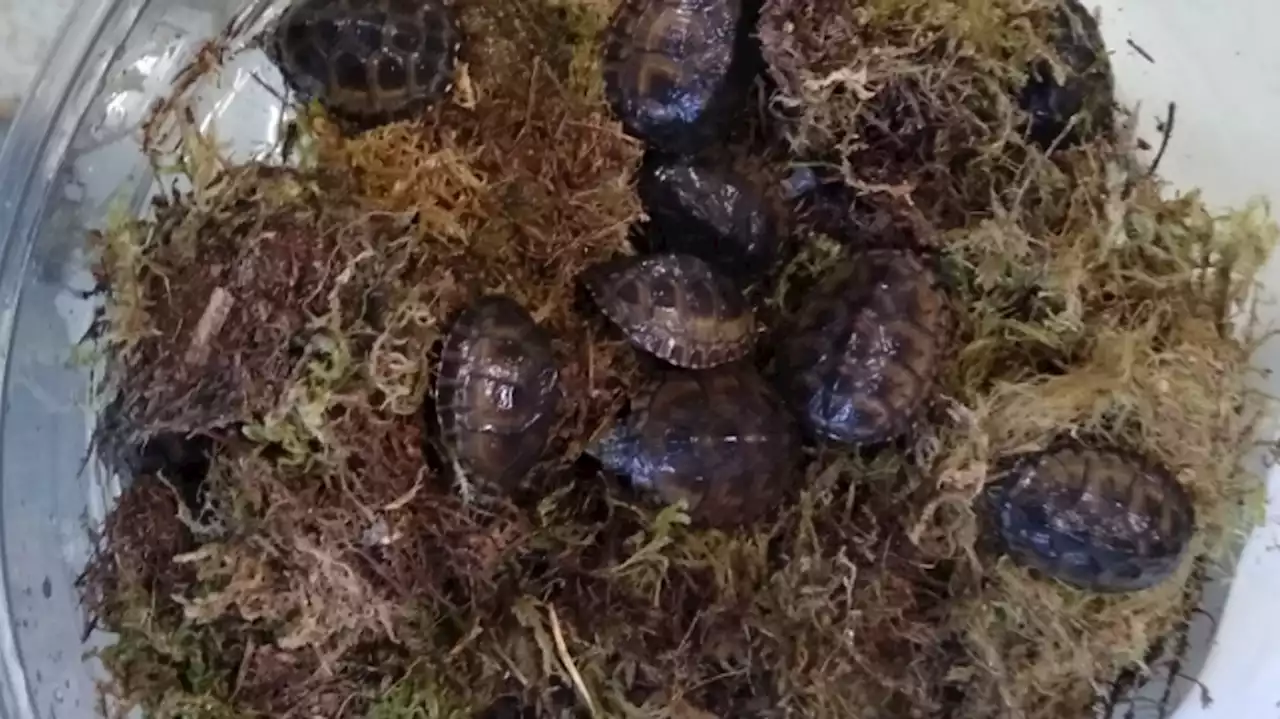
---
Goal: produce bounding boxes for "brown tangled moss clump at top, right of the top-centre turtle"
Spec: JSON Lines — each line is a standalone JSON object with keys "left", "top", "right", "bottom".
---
{"left": 759, "top": 0, "right": 1110, "bottom": 235}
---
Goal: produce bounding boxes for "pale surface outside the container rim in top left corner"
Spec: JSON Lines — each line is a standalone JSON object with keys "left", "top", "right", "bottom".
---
{"left": 0, "top": 0, "right": 76, "bottom": 123}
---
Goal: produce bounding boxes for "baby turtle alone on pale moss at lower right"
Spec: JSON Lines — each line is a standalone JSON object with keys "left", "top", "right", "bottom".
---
{"left": 987, "top": 443, "right": 1196, "bottom": 592}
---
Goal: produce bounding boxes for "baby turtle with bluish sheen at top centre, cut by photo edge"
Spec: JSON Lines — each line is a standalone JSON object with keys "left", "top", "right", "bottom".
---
{"left": 603, "top": 0, "right": 751, "bottom": 154}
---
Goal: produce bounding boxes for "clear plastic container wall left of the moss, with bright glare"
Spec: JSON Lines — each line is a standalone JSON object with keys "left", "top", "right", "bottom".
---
{"left": 0, "top": 0, "right": 282, "bottom": 719}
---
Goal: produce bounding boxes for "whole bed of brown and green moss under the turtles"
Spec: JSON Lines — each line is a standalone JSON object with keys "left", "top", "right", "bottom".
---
{"left": 82, "top": 0, "right": 1275, "bottom": 719}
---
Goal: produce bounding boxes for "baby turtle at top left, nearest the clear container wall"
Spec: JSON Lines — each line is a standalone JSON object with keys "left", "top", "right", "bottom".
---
{"left": 270, "top": 0, "right": 461, "bottom": 124}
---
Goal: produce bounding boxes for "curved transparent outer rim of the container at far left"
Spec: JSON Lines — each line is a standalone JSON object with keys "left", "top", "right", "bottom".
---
{"left": 0, "top": 0, "right": 145, "bottom": 719}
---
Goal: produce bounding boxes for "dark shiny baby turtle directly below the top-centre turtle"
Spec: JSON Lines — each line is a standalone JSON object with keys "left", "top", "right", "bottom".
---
{"left": 637, "top": 160, "right": 781, "bottom": 280}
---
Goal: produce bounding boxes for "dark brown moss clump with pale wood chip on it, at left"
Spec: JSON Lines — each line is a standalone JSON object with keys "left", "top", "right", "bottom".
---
{"left": 90, "top": 165, "right": 378, "bottom": 434}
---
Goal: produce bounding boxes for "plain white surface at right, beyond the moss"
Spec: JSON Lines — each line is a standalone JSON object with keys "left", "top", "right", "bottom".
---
{"left": 1085, "top": 0, "right": 1280, "bottom": 719}
